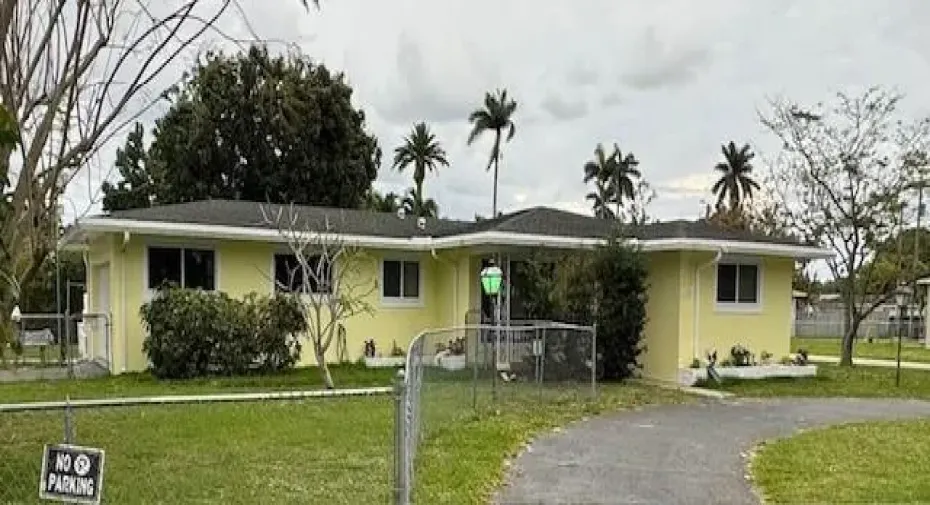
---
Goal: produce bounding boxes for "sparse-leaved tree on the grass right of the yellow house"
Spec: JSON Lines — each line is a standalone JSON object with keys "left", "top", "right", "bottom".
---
{"left": 760, "top": 87, "right": 930, "bottom": 365}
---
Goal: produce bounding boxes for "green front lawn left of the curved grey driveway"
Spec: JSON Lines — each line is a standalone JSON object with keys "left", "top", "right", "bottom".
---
{"left": 0, "top": 367, "right": 684, "bottom": 505}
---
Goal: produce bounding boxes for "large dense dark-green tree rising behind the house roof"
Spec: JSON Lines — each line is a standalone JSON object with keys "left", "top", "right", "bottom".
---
{"left": 100, "top": 46, "right": 381, "bottom": 211}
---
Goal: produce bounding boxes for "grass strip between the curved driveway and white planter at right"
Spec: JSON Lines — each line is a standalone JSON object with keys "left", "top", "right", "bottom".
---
{"left": 704, "top": 364, "right": 930, "bottom": 399}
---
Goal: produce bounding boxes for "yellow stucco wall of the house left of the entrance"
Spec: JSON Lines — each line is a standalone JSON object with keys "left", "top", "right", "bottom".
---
{"left": 88, "top": 235, "right": 477, "bottom": 373}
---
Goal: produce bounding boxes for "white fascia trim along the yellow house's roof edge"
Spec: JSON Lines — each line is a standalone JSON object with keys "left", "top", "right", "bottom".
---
{"left": 75, "top": 217, "right": 835, "bottom": 259}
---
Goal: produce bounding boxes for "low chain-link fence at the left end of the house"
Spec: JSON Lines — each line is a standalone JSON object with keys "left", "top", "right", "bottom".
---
{"left": 0, "top": 314, "right": 112, "bottom": 381}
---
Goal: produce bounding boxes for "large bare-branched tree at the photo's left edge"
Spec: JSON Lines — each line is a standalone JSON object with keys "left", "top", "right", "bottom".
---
{"left": 0, "top": 0, "right": 231, "bottom": 338}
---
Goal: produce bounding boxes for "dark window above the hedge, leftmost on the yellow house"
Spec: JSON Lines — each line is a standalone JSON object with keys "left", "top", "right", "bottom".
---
{"left": 148, "top": 247, "right": 216, "bottom": 291}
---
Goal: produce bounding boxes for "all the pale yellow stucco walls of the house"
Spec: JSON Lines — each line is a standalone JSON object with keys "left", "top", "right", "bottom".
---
{"left": 87, "top": 229, "right": 794, "bottom": 380}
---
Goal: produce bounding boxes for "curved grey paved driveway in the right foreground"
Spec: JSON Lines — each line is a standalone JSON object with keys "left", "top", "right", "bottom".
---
{"left": 495, "top": 399, "right": 930, "bottom": 505}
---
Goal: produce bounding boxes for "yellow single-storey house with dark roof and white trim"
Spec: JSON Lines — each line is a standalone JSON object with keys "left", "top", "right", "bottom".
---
{"left": 63, "top": 200, "right": 831, "bottom": 380}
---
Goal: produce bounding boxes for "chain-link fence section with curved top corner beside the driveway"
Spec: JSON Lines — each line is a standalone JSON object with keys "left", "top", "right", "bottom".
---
{"left": 394, "top": 321, "right": 597, "bottom": 505}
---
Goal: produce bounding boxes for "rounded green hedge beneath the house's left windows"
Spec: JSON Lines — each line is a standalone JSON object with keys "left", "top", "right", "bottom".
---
{"left": 140, "top": 287, "right": 307, "bottom": 379}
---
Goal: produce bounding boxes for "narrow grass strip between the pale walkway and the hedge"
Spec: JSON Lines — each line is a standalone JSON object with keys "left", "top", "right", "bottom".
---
{"left": 0, "top": 365, "right": 396, "bottom": 403}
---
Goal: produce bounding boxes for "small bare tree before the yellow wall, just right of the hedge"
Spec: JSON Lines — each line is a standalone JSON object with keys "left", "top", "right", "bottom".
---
{"left": 262, "top": 205, "right": 377, "bottom": 389}
